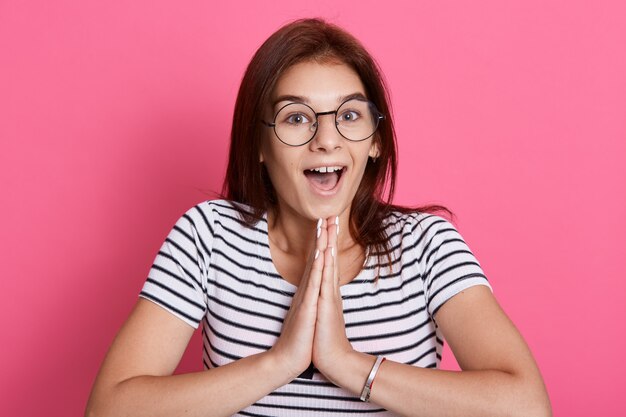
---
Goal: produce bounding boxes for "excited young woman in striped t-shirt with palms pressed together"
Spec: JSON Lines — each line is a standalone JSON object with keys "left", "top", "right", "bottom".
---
{"left": 87, "top": 20, "right": 551, "bottom": 417}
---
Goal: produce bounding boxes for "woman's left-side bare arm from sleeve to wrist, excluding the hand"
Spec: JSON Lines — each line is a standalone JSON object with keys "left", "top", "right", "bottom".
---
{"left": 85, "top": 299, "right": 290, "bottom": 417}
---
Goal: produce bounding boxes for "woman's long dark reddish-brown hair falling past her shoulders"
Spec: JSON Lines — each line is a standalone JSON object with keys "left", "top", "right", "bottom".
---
{"left": 222, "top": 19, "right": 452, "bottom": 264}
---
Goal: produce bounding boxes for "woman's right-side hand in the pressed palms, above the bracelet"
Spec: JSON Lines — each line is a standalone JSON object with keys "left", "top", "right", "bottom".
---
{"left": 313, "top": 217, "right": 353, "bottom": 381}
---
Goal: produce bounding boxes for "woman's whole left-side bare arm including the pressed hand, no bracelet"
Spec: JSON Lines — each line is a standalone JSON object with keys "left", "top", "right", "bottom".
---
{"left": 85, "top": 218, "right": 326, "bottom": 417}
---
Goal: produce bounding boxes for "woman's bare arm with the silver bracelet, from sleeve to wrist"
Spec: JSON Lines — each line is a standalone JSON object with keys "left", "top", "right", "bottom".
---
{"left": 322, "top": 284, "right": 551, "bottom": 417}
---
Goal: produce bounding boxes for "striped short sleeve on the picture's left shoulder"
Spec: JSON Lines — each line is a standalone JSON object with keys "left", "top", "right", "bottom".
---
{"left": 139, "top": 205, "right": 213, "bottom": 328}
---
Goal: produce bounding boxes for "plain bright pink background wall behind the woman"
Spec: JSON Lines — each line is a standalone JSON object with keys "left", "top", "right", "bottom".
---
{"left": 0, "top": 0, "right": 626, "bottom": 416}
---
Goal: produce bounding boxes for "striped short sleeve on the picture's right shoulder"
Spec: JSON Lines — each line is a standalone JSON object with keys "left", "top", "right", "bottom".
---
{"left": 417, "top": 215, "right": 491, "bottom": 320}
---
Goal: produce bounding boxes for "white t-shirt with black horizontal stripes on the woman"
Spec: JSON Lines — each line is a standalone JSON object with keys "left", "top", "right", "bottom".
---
{"left": 140, "top": 200, "right": 489, "bottom": 417}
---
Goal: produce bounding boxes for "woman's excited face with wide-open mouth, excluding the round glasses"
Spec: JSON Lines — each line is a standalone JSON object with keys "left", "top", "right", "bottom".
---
{"left": 260, "top": 61, "right": 378, "bottom": 220}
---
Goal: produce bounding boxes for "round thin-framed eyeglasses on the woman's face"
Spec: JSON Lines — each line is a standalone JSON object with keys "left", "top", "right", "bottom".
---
{"left": 263, "top": 98, "right": 385, "bottom": 146}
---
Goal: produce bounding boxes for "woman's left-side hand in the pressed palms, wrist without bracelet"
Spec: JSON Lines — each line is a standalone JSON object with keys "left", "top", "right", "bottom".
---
{"left": 270, "top": 219, "right": 330, "bottom": 379}
